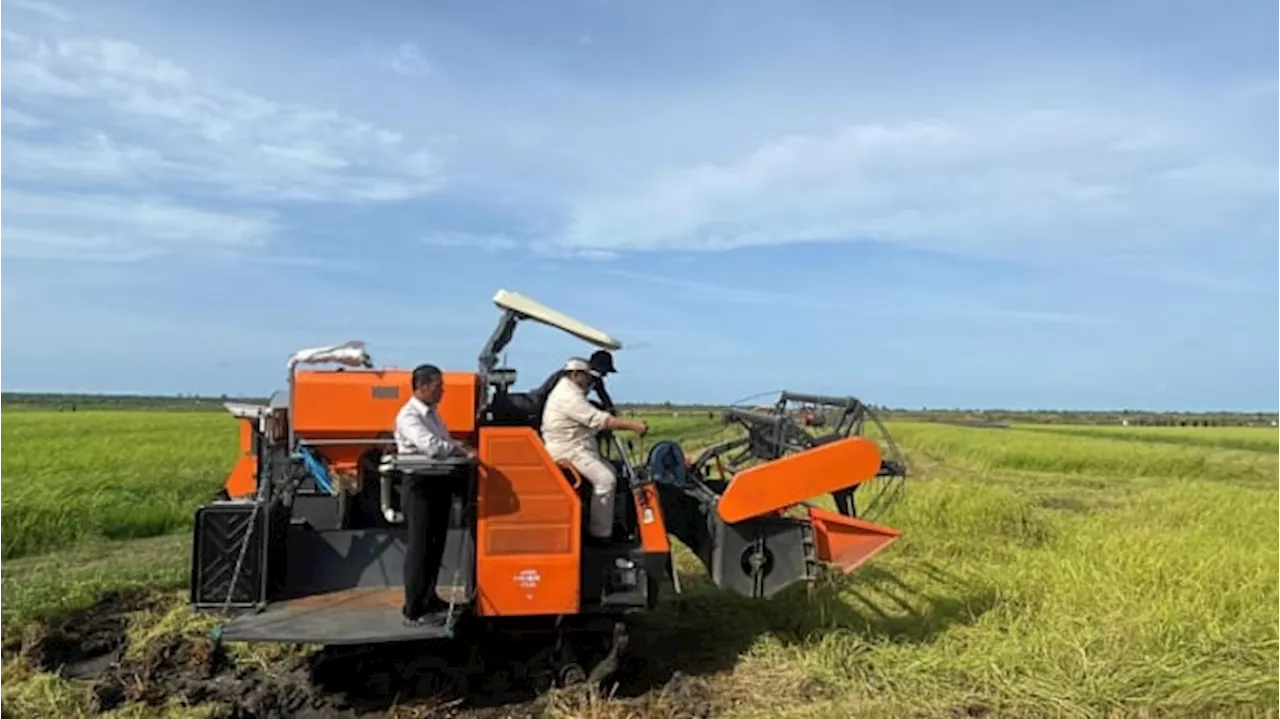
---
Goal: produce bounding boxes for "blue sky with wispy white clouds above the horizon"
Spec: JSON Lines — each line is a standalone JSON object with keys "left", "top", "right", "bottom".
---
{"left": 0, "top": 0, "right": 1280, "bottom": 409}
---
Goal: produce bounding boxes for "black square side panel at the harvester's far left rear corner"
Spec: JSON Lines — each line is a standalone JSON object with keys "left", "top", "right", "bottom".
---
{"left": 191, "top": 502, "right": 288, "bottom": 608}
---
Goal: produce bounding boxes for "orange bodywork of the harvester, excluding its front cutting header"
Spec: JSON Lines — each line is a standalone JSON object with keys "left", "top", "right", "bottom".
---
{"left": 225, "top": 370, "right": 671, "bottom": 617}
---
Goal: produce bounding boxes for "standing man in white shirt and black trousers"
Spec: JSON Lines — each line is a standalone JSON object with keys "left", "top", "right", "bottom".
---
{"left": 396, "top": 365, "right": 476, "bottom": 626}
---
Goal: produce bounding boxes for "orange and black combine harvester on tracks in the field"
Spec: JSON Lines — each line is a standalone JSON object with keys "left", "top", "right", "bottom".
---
{"left": 191, "top": 290, "right": 906, "bottom": 681}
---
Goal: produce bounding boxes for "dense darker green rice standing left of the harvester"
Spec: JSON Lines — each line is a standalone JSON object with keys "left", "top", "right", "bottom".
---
{"left": 0, "top": 412, "right": 239, "bottom": 559}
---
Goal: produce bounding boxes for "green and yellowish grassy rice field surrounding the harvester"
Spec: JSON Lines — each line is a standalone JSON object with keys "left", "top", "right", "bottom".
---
{"left": 0, "top": 412, "right": 1280, "bottom": 718}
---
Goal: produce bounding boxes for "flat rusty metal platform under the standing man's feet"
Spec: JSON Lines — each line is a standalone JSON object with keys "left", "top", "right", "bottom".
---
{"left": 223, "top": 587, "right": 445, "bottom": 645}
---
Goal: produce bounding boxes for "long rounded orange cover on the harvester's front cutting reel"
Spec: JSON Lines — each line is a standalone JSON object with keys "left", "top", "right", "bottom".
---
{"left": 718, "top": 436, "right": 881, "bottom": 523}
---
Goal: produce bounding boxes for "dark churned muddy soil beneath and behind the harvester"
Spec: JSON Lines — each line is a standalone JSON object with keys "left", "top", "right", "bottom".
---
{"left": 27, "top": 594, "right": 716, "bottom": 719}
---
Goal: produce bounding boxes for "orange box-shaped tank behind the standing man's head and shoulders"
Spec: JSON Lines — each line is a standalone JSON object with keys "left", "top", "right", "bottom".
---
{"left": 292, "top": 370, "right": 479, "bottom": 439}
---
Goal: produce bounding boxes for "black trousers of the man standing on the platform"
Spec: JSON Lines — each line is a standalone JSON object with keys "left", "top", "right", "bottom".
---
{"left": 401, "top": 475, "right": 456, "bottom": 618}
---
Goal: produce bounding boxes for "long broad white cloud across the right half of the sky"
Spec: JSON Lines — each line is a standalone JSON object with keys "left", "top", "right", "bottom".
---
{"left": 554, "top": 113, "right": 1280, "bottom": 257}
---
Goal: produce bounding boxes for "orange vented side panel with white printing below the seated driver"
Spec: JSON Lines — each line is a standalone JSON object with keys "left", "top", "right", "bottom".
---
{"left": 476, "top": 427, "right": 582, "bottom": 617}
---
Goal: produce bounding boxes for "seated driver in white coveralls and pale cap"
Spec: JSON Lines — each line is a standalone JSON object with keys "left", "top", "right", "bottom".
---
{"left": 541, "top": 357, "right": 649, "bottom": 541}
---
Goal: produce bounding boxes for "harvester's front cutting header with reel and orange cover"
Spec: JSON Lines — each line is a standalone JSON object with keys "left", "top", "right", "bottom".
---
{"left": 645, "top": 391, "right": 906, "bottom": 597}
